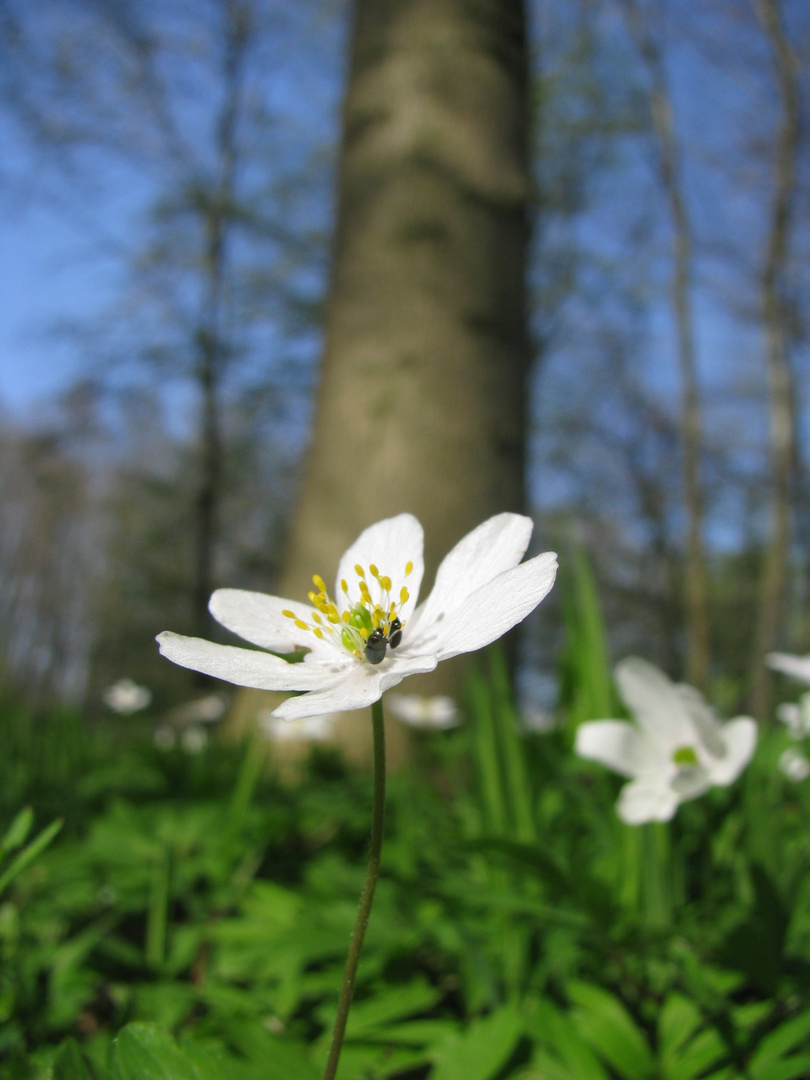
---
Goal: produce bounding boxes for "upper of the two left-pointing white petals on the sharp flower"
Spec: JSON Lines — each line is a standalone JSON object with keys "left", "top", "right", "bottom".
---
{"left": 208, "top": 589, "right": 328, "bottom": 652}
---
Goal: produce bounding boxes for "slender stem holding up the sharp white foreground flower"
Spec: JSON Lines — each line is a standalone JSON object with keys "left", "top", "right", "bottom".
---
{"left": 324, "top": 700, "right": 386, "bottom": 1080}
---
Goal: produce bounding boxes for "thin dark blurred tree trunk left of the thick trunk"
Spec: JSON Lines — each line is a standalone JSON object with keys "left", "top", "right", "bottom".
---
{"left": 193, "top": 5, "right": 248, "bottom": 636}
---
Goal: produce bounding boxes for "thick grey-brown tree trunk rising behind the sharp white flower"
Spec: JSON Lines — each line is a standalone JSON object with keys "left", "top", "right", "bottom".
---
{"left": 231, "top": 0, "right": 529, "bottom": 751}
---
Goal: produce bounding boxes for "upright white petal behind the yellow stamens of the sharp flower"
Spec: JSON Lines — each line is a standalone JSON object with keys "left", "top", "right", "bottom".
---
{"left": 335, "top": 514, "right": 424, "bottom": 620}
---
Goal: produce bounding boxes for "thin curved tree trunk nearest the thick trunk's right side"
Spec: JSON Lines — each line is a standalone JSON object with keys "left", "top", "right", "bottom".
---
{"left": 622, "top": 0, "right": 711, "bottom": 690}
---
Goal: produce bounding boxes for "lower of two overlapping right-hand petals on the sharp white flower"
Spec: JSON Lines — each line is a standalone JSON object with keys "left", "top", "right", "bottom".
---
{"left": 403, "top": 551, "right": 557, "bottom": 660}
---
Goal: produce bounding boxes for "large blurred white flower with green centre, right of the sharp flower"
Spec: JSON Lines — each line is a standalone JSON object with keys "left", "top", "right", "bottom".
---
{"left": 575, "top": 657, "right": 757, "bottom": 825}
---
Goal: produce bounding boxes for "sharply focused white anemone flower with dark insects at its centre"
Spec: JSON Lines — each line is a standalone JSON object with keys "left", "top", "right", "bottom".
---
{"left": 158, "top": 514, "right": 556, "bottom": 720}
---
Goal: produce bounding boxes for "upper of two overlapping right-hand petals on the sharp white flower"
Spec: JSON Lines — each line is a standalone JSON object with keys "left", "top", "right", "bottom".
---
{"left": 410, "top": 514, "right": 534, "bottom": 634}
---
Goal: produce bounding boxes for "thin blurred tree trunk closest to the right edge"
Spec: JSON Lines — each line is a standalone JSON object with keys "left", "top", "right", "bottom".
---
{"left": 751, "top": 0, "right": 799, "bottom": 718}
